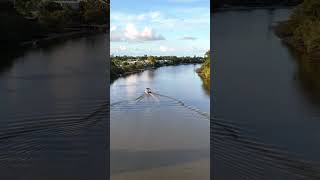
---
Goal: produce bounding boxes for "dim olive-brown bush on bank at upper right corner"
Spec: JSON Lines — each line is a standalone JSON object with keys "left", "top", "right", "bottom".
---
{"left": 274, "top": 0, "right": 320, "bottom": 60}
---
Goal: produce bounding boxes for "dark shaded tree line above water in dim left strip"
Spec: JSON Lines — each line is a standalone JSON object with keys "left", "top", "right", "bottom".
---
{"left": 0, "top": 0, "right": 109, "bottom": 48}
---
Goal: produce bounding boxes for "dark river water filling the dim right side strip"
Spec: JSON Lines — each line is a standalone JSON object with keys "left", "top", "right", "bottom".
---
{"left": 211, "top": 9, "right": 320, "bottom": 180}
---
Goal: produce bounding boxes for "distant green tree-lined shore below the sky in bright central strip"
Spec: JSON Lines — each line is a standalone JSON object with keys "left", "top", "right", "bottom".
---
{"left": 110, "top": 55, "right": 204, "bottom": 80}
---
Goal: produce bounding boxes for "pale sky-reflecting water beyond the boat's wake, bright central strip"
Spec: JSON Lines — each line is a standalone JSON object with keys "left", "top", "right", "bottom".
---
{"left": 110, "top": 64, "right": 210, "bottom": 112}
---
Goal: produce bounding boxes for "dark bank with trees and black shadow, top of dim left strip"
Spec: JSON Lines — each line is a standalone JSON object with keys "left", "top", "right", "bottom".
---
{"left": 0, "top": 0, "right": 108, "bottom": 49}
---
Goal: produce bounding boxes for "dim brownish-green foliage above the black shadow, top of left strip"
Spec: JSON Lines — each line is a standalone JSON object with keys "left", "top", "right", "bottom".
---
{"left": 16, "top": 0, "right": 109, "bottom": 30}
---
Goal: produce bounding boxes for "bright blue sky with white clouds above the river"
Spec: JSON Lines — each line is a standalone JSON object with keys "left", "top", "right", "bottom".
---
{"left": 110, "top": 0, "right": 210, "bottom": 56}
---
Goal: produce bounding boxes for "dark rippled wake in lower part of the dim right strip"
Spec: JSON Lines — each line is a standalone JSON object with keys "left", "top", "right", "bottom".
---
{"left": 210, "top": 117, "right": 320, "bottom": 180}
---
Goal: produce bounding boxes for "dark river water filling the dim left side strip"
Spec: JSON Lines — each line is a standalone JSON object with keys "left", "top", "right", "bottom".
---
{"left": 0, "top": 34, "right": 109, "bottom": 180}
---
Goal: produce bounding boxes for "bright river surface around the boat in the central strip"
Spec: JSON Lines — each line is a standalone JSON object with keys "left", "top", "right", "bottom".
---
{"left": 110, "top": 65, "right": 210, "bottom": 180}
